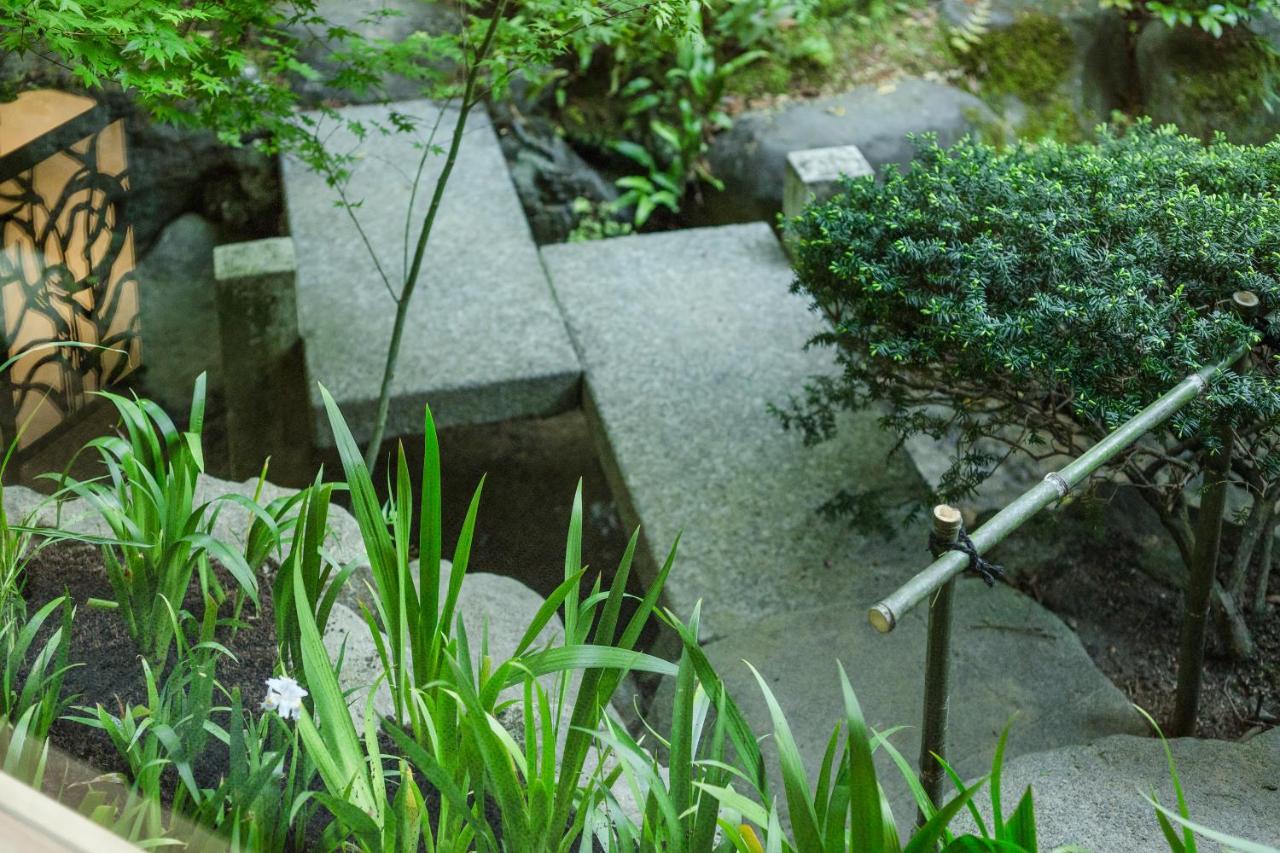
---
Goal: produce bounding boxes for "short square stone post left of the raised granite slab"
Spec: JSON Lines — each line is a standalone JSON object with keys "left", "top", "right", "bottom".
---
{"left": 214, "top": 237, "right": 312, "bottom": 483}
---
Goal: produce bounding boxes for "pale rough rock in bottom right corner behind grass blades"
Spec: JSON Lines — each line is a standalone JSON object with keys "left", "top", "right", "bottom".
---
{"left": 955, "top": 729, "right": 1280, "bottom": 853}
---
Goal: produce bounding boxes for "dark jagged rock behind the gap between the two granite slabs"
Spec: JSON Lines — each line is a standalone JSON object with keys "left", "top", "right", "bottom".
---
{"left": 494, "top": 108, "right": 618, "bottom": 245}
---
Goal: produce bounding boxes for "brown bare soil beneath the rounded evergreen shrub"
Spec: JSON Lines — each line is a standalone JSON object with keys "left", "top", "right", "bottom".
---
{"left": 1002, "top": 499, "right": 1280, "bottom": 740}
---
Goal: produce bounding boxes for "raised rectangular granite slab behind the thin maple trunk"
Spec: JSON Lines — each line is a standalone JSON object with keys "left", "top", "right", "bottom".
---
{"left": 283, "top": 101, "right": 580, "bottom": 446}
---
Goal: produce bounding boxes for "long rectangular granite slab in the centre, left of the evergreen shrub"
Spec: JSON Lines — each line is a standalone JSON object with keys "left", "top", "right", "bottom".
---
{"left": 543, "top": 223, "right": 927, "bottom": 637}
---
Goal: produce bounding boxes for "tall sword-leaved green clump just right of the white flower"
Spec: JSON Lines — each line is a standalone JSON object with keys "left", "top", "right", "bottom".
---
{"left": 305, "top": 392, "right": 675, "bottom": 853}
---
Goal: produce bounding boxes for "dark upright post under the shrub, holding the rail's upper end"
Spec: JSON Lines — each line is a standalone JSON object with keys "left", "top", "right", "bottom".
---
{"left": 1169, "top": 291, "right": 1260, "bottom": 738}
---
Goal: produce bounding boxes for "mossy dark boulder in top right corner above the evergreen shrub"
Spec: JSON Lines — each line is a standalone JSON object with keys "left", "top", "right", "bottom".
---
{"left": 1137, "top": 20, "right": 1280, "bottom": 145}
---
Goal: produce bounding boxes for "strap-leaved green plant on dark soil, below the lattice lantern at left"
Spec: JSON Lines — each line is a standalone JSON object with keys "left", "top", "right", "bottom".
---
{"left": 52, "top": 374, "right": 279, "bottom": 670}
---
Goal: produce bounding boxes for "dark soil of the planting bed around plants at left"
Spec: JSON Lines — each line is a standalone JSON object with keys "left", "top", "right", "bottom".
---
{"left": 26, "top": 543, "right": 276, "bottom": 786}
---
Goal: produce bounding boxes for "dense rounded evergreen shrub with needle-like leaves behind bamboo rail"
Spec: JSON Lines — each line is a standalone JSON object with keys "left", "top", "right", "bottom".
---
{"left": 783, "top": 123, "right": 1280, "bottom": 556}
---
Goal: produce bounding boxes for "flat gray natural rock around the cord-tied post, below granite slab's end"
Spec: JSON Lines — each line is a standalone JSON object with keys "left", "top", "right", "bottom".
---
{"left": 650, "top": 578, "right": 1144, "bottom": 829}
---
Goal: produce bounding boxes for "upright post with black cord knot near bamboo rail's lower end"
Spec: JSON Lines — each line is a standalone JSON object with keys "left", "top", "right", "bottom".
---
{"left": 916, "top": 503, "right": 961, "bottom": 825}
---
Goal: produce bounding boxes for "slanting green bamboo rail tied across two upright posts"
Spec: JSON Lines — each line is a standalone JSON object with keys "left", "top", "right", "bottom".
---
{"left": 867, "top": 333, "right": 1249, "bottom": 634}
